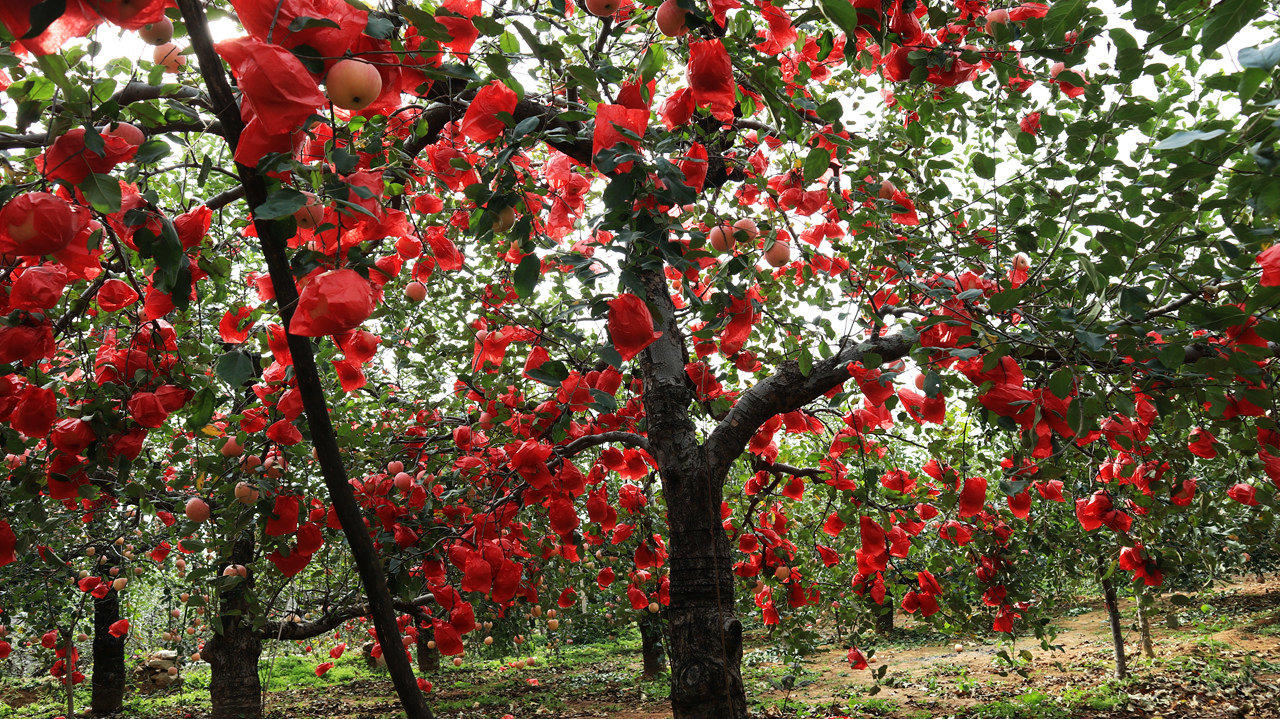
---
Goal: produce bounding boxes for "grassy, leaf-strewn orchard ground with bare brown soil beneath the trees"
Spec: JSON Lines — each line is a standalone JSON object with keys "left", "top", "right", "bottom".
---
{"left": 0, "top": 574, "right": 1280, "bottom": 719}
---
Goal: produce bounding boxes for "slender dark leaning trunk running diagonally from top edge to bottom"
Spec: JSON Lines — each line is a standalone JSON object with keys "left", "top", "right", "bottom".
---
{"left": 178, "top": 0, "right": 431, "bottom": 719}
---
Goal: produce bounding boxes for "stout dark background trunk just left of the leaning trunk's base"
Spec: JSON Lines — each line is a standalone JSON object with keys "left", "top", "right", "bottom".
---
{"left": 200, "top": 531, "right": 262, "bottom": 719}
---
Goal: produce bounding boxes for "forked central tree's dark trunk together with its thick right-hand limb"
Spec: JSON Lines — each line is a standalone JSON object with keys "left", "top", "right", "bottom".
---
{"left": 632, "top": 257, "right": 914, "bottom": 719}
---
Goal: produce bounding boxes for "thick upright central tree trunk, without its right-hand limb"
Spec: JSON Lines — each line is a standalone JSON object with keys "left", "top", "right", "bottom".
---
{"left": 640, "top": 270, "right": 746, "bottom": 719}
